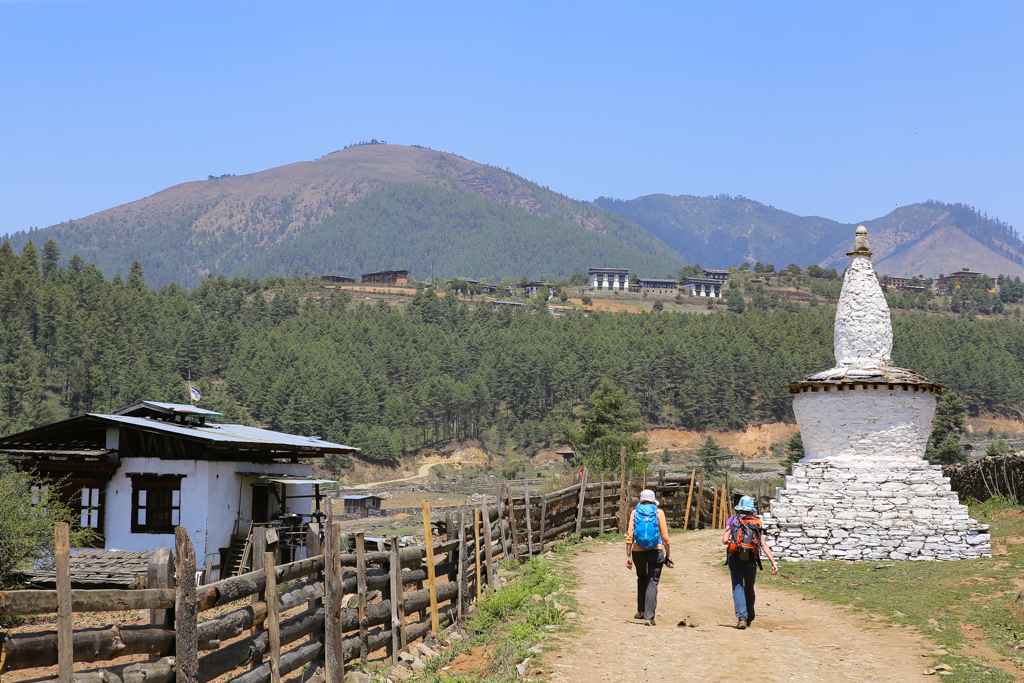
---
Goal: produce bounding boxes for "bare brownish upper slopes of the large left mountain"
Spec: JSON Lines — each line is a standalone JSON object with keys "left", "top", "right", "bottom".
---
{"left": 11, "top": 144, "right": 681, "bottom": 286}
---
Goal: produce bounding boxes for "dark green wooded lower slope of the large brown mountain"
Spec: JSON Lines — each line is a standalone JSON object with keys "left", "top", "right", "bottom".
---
{"left": 233, "top": 183, "right": 683, "bottom": 278}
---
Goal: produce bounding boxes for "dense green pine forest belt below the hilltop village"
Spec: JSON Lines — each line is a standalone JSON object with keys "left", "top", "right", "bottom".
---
{"left": 0, "top": 237, "right": 1024, "bottom": 466}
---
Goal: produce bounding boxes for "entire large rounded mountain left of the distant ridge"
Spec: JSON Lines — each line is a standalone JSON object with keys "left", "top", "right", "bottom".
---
{"left": 11, "top": 141, "right": 685, "bottom": 287}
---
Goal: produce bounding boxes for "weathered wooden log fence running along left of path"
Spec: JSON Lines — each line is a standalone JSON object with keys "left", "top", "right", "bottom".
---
{"left": 0, "top": 471, "right": 732, "bottom": 683}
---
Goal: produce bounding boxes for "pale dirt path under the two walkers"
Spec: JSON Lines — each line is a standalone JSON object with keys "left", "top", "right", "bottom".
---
{"left": 544, "top": 531, "right": 935, "bottom": 683}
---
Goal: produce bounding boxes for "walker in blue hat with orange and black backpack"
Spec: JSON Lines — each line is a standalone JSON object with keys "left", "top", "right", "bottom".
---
{"left": 722, "top": 496, "right": 778, "bottom": 629}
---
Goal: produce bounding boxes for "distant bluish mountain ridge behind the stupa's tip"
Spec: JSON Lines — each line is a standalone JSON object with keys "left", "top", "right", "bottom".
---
{"left": 596, "top": 195, "right": 1024, "bottom": 276}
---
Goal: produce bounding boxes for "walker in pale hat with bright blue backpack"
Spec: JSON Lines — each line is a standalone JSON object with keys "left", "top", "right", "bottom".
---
{"left": 626, "top": 488, "right": 672, "bottom": 626}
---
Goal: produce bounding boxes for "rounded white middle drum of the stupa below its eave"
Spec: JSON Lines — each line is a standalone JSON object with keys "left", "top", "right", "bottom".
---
{"left": 793, "top": 384, "right": 936, "bottom": 462}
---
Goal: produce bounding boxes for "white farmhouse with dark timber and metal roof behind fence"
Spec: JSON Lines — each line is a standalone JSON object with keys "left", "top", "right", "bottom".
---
{"left": 0, "top": 401, "right": 358, "bottom": 581}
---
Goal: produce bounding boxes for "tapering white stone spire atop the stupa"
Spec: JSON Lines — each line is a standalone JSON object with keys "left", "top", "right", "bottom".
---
{"left": 834, "top": 225, "right": 893, "bottom": 368}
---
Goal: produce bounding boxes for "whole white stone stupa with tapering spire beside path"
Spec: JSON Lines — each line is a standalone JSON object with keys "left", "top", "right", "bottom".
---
{"left": 763, "top": 225, "right": 991, "bottom": 561}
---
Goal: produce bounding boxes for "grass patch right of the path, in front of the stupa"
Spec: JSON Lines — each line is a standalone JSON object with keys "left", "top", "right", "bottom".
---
{"left": 759, "top": 499, "right": 1024, "bottom": 683}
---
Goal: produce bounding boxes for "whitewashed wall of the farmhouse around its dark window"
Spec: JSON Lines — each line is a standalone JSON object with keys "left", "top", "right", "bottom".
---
{"left": 103, "top": 458, "right": 312, "bottom": 564}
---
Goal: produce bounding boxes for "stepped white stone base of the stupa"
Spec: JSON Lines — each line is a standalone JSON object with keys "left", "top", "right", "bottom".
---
{"left": 762, "top": 458, "right": 992, "bottom": 562}
